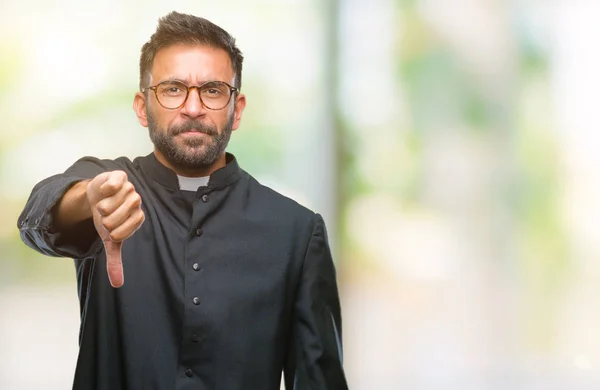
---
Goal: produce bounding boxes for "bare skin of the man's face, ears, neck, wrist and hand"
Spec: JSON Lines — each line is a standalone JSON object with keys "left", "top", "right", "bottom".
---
{"left": 54, "top": 45, "right": 246, "bottom": 287}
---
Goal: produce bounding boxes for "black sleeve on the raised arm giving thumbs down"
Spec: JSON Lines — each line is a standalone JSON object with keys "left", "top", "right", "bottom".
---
{"left": 17, "top": 157, "right": 120, "bottom": 259}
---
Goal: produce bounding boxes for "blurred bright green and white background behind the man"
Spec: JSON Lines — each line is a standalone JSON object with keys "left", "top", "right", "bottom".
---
{"left": 0, "top": 0, "right": 600, "bottom": 390}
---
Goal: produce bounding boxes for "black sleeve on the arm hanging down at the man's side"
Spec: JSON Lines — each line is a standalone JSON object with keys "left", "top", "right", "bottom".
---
{"left": 284, "top": 214, "right": 348, "bottom": 390}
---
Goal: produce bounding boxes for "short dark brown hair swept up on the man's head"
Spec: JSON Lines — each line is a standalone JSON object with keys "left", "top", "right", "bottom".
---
{"left": 140, "top": 11, "right": 244, "bottom": 90}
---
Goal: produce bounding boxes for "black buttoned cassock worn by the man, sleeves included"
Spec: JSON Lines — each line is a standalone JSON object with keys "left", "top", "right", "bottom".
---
{"left": 18, "top": 154, "right": 347, "bottom": 390}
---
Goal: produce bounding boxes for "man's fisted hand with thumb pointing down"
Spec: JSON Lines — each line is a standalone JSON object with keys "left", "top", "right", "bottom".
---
{"left": 86, "top": 171, "right": 145, "bottom": 287}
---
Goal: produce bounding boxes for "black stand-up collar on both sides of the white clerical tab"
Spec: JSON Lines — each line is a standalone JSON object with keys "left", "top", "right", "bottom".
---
{"left": 136, "top": 153, "right": 242, "bottom": 191}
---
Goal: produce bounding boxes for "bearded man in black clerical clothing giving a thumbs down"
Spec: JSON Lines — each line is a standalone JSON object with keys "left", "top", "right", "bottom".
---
{"left": 18, "top": 12, "right": 347, "bottom": 390}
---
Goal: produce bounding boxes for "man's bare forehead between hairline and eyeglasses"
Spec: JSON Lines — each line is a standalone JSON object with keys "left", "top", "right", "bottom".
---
{"left": 151, "top": 45, "right": 234, "bottom": 84}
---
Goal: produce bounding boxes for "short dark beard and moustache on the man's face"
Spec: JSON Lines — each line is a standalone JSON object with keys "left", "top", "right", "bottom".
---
{"left": 146, "top": 111, "right": 234, "bottom": 170}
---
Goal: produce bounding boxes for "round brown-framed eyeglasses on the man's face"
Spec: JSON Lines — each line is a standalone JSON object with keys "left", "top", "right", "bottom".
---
{"left": 142, "top": 80, "right": 239, "bottom": 110}
